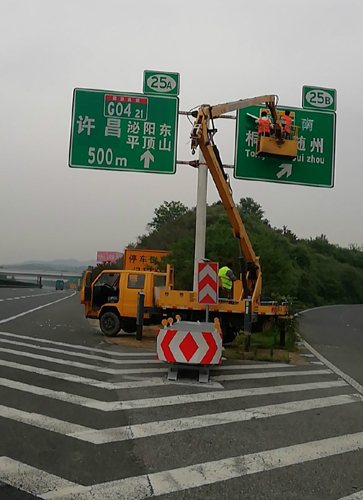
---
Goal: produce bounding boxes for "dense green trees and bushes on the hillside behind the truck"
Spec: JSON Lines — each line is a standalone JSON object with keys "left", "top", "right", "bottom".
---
{"left": 135, "top": 198, "right": 363, "bottom": 306}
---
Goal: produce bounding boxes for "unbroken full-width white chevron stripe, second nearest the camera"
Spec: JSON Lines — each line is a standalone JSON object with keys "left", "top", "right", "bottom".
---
{"left": 0, "top": 394, "right": 363, "bottom": 444}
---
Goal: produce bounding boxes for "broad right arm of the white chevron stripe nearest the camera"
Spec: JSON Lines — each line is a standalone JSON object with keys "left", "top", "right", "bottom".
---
{"left": 43, "top": 432, "right": 363, "bottom": 500}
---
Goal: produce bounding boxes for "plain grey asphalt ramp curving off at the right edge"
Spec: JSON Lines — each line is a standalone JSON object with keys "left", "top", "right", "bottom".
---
{"left": 300, "top": 305, "right": 363, "bottom": 385}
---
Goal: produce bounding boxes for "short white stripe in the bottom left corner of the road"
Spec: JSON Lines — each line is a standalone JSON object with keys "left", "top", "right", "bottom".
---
{"left": 0, "top": 457, "right": 89, "bottom": 496}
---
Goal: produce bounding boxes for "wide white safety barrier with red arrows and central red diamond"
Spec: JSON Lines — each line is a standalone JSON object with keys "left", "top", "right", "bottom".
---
{"left": 157, "top": 321, "right": 222, "bottom": 365}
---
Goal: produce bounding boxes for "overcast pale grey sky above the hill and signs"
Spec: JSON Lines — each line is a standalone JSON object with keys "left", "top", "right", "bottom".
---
{"left": 0, "top": 0, "right": 363, "bottom": 263}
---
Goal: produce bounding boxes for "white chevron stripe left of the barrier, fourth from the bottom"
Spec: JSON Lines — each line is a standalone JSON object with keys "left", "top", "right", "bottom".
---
{"left": 1, "top": 360, "right": 169, "bottom": 391}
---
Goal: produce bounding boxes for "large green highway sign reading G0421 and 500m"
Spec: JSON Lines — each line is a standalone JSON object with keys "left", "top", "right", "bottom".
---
{"left": 69, "top": 89, "right": 179, "bottom": 174}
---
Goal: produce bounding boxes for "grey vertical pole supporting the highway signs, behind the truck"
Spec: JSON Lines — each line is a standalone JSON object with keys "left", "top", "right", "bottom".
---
{"left": 193, "top": 149, "right": 208, "bottom": 292}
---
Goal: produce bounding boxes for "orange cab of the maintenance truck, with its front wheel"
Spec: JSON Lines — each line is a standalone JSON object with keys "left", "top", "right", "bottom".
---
{"left": 81, "top": 265, "right": 174, "bottom": 337}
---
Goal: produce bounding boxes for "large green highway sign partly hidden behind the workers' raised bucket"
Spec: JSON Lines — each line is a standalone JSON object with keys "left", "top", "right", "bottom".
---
{"left": 234, "top": 106, "right": 336, "bottom": 187}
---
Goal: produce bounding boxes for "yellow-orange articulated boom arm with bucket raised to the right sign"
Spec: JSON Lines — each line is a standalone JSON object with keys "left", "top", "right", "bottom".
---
{"left": 191, "top": 95, "right": 297, "bottom": 306}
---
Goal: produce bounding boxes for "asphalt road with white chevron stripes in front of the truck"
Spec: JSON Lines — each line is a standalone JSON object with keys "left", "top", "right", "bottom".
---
{"left": 0, "top": 292, "right": 363, "bottom": 500}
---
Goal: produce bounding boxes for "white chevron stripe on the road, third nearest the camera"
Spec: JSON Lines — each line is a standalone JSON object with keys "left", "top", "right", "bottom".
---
{"left": 0, "top": 378, "right": 347, "bottom": 412}
